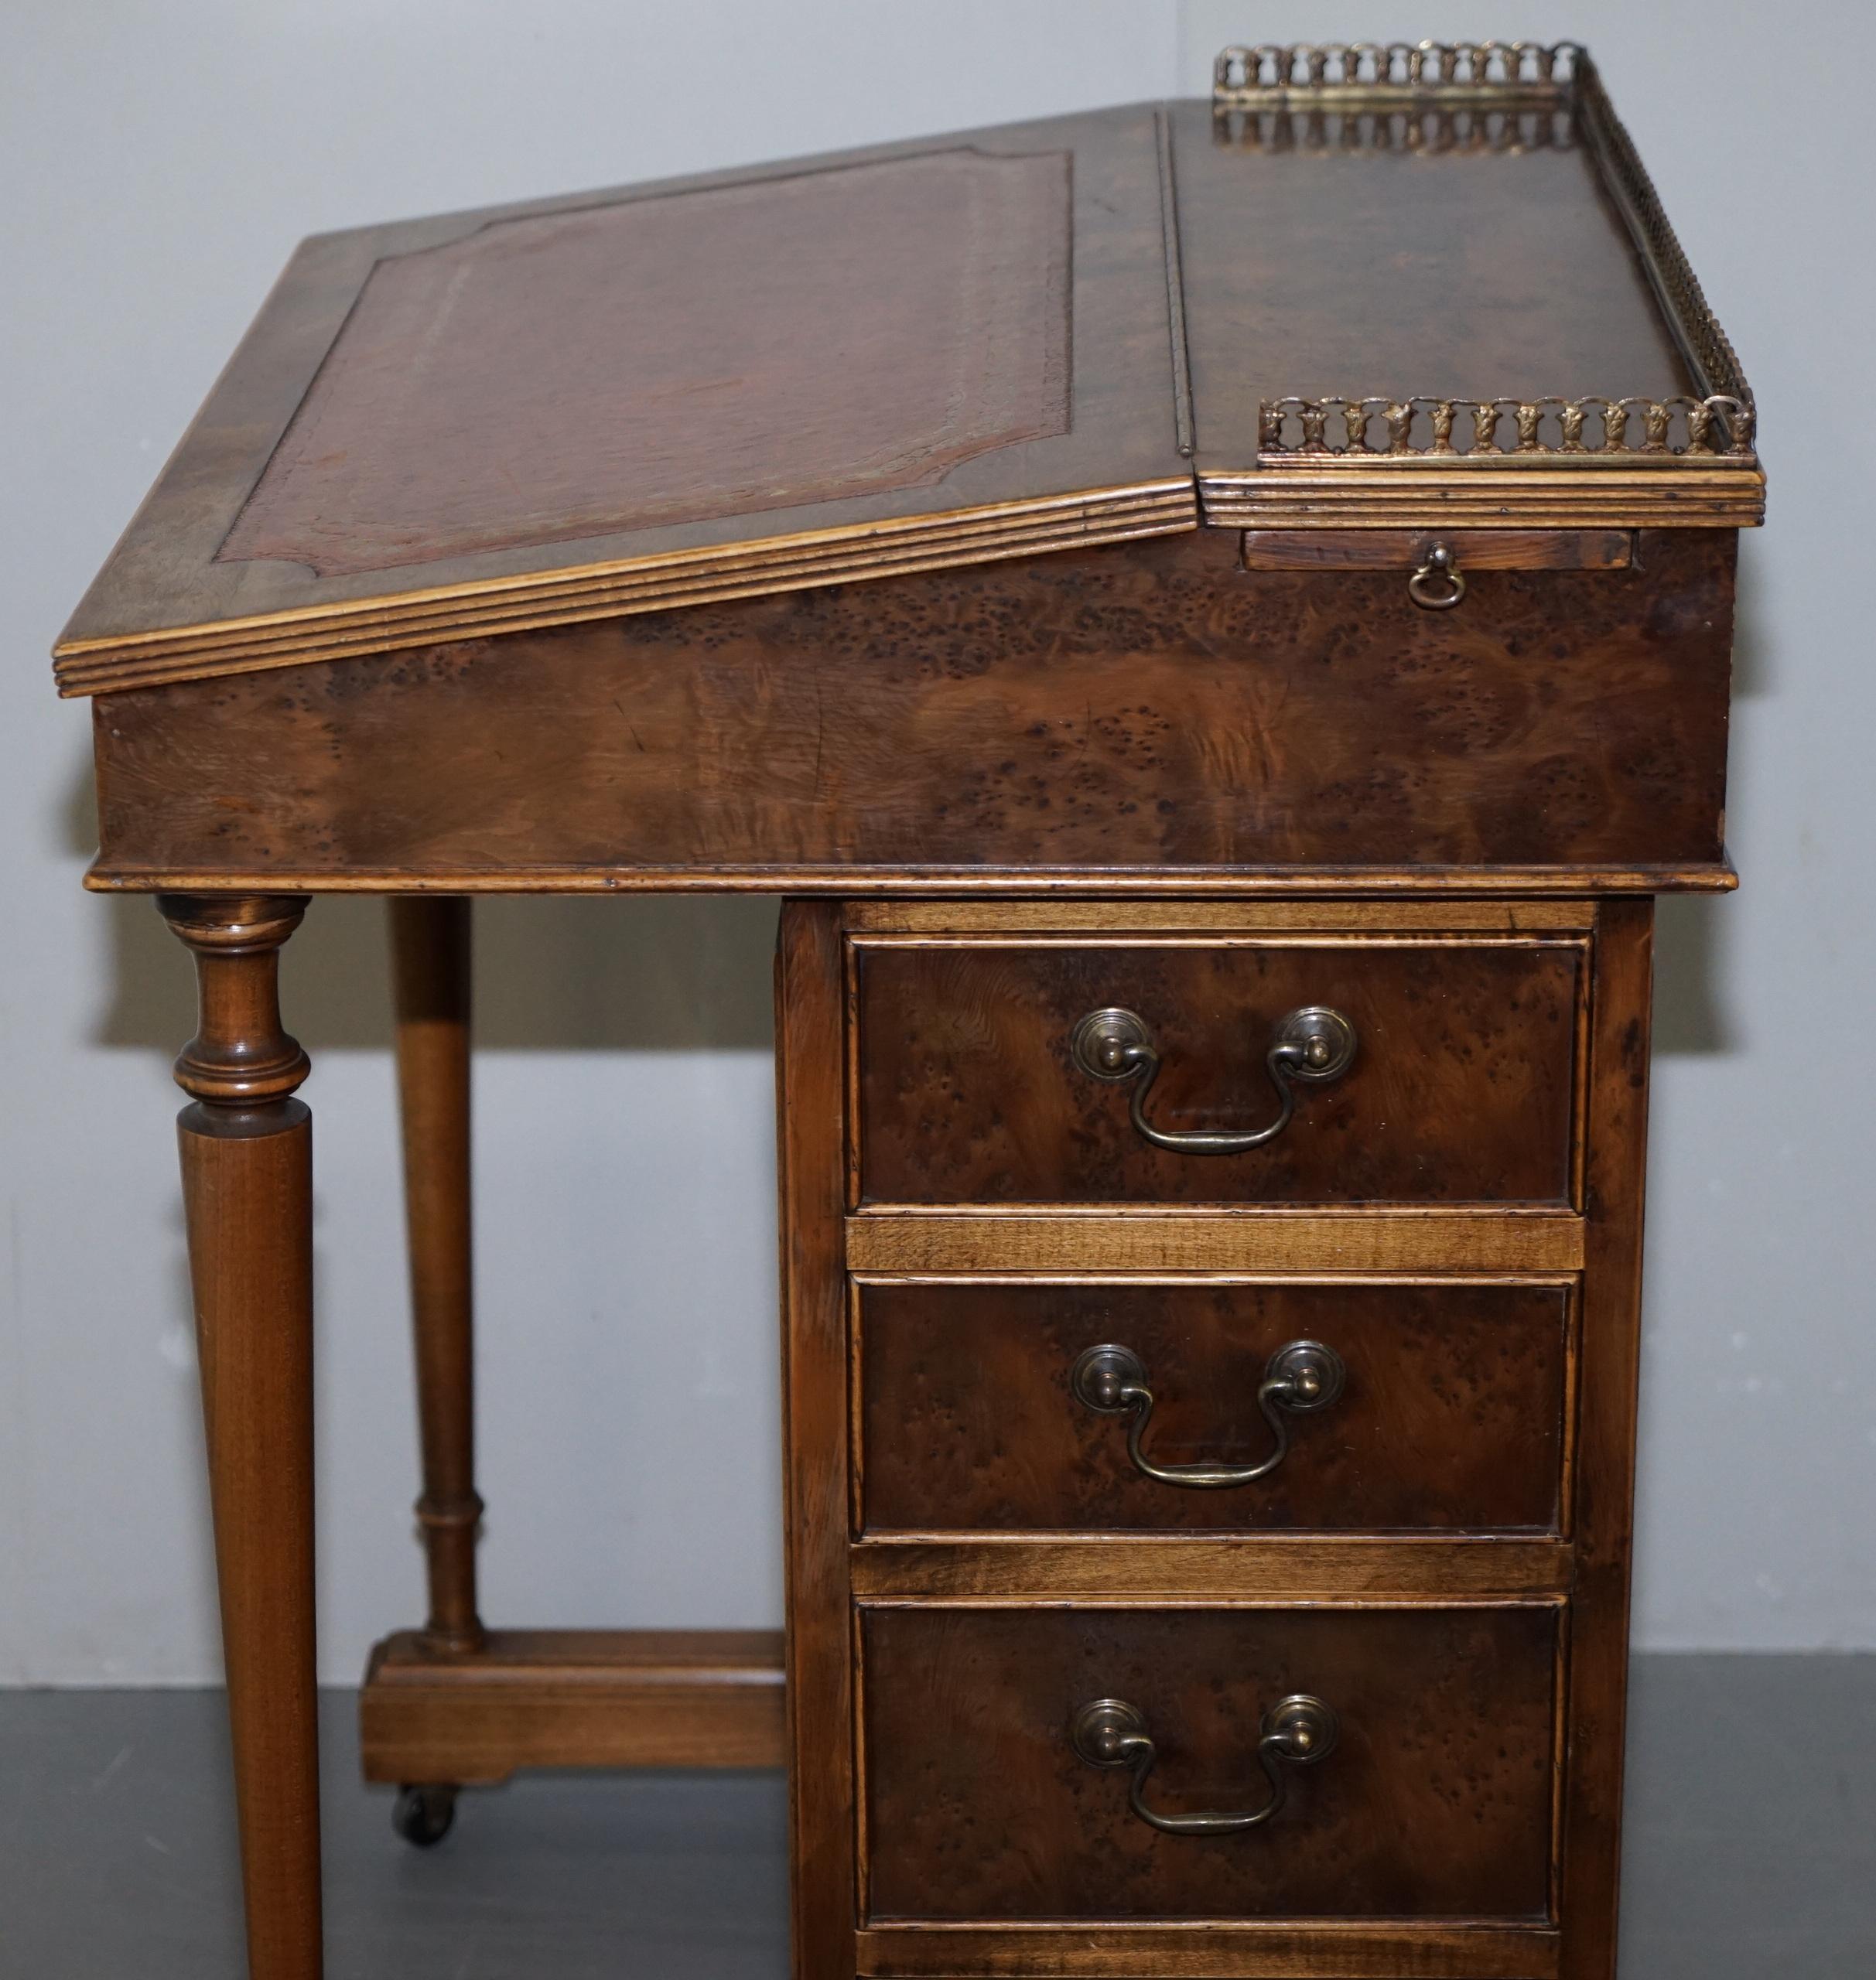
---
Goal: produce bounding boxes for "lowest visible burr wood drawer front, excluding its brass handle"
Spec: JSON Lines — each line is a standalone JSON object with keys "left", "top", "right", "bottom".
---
{"left": 863, "top": 1608, "right": 1557, "bottom": 1920}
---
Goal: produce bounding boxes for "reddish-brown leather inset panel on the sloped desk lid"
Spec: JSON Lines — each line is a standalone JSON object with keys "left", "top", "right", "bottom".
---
{"left": 216, "top": 148, "right": 1074, "bottom": 576}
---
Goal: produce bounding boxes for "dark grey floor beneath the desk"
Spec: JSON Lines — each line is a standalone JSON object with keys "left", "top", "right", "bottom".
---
{"left": 0, "top": 1657, "right": 1876, "bottom": 1980}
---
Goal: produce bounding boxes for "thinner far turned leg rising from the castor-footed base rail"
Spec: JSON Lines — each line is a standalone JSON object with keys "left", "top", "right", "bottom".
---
{"left": 390, "top": 895, "right": 484, "bottom": 1651}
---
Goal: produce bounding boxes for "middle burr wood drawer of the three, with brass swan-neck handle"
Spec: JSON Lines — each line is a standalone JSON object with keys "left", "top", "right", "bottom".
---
{"left": 856, "top": 1279, "right": 1571, "bottom": 1532}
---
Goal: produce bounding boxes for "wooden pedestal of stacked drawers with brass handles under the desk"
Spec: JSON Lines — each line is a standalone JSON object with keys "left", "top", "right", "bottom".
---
{"left": 781, "top": 899, "right": 1649, "bottom": 1980}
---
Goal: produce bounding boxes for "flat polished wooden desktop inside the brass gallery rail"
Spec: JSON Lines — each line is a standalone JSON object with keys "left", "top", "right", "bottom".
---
{"left": 1170, "top": 103, "right": 1692, "bottom": 457}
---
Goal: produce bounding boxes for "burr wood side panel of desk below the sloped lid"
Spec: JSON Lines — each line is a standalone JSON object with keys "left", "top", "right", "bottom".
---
{"left": 84, "top": 531, "right": 1735, "bottom": 891}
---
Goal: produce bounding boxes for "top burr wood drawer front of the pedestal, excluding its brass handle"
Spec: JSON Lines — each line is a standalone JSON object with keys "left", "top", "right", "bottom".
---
{"left": 856, "top": 940, "right": 1583, "bottom": 1203}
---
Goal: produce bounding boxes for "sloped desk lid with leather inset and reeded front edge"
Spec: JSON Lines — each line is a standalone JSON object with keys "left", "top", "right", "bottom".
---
{"left": 56, "top": 105, "right": 1198, "bottom": 695}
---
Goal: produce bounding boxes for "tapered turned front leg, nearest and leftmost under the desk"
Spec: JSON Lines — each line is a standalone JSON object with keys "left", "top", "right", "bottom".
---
{"left": 159, "top": 895, "right": 323, "bottom": 1980}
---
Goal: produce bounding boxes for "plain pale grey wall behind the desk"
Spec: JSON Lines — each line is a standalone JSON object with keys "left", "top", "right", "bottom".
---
{"left": 0, "top": 0, "right": 1876, "bottom": 1683}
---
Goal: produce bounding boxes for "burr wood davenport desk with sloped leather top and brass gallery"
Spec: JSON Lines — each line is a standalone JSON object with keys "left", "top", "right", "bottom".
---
{"left": 57, "top": 43, "right": 1763, "bottom": 1980}
